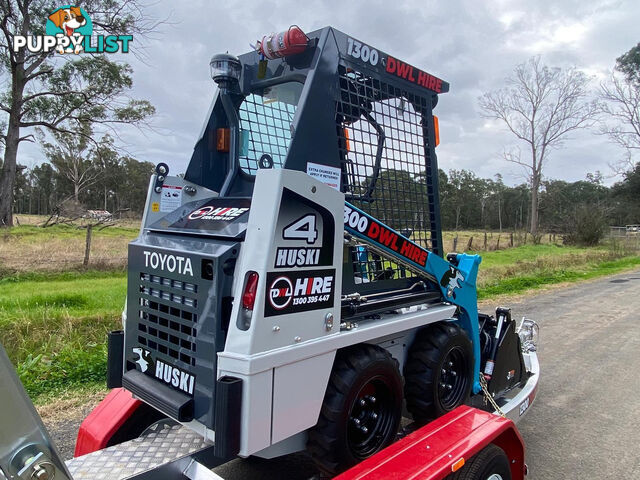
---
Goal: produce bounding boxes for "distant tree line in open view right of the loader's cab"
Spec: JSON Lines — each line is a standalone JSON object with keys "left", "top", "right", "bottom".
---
{"left": 439, "top": 167, "right": 640, "bottom": 233}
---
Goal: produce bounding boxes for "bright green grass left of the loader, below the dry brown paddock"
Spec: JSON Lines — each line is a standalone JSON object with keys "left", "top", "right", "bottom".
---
{"left": 0, "top": 272, "right": 126, "bottom": 397}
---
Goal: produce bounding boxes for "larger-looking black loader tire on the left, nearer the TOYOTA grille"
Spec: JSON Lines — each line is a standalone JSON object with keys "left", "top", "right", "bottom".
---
{"left": 307, "top": 345, "right": 402, "bottom": 476}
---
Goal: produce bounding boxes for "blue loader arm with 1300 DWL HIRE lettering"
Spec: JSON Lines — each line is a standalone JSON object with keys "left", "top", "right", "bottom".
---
{"left": 344, "top": 202, "right": 482, "bottom": 393}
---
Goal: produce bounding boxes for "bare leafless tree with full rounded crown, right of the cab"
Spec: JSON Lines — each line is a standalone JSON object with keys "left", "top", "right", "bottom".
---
{"left": 479, "top": 56, "right": 597, "bottom": 238}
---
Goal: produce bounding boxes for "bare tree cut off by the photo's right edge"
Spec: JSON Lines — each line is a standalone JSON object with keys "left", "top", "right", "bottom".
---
{"left": 600, "top": 73, "right": 640, "bottom": 173}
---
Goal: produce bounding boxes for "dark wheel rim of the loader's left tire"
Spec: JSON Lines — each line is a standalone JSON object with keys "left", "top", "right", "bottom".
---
{"left": 347, "top": 377, "right": 394, "bottom": 459}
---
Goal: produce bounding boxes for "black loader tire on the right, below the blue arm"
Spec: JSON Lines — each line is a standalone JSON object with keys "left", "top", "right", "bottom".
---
{"left": 404, "top": 322, "right": 473, "bottom": 425}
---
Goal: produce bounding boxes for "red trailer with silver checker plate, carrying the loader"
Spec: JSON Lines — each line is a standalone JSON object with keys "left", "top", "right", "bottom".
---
{"left": 69, "top": 388, "right": 536, "bottom": 480}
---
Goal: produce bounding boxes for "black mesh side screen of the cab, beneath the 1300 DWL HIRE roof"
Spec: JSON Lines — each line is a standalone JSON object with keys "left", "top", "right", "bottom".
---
{"left": 336, "top": 63, "right": 437, "bottom": 281}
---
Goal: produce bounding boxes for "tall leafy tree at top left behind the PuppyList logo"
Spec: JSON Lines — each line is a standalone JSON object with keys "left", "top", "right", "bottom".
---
{"left": 0, "top": 0, "right": 162, "bottom": 227}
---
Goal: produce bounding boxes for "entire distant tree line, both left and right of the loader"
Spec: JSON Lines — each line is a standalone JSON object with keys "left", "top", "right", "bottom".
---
{"left": 10, "top": 158, "right": 640, "bottom": 233}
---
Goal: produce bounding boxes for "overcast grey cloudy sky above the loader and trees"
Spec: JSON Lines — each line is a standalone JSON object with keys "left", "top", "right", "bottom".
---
{"left": 20, "top": 0, "right": 640, "bottom": 184}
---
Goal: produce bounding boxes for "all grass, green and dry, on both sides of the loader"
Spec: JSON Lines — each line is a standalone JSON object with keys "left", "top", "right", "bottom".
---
{"left": 0, "top": 222, "right": 640, "bottom": 404}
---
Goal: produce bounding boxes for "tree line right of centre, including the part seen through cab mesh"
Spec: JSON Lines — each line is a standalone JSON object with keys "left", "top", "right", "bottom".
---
{"left": 363, "top": 163, "right": 640, "bottom": 238}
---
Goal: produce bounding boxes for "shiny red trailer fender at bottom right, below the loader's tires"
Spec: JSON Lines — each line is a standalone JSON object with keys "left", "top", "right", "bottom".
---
{"left": 335, "top": 405, "right": 526, "bottom": 480}
